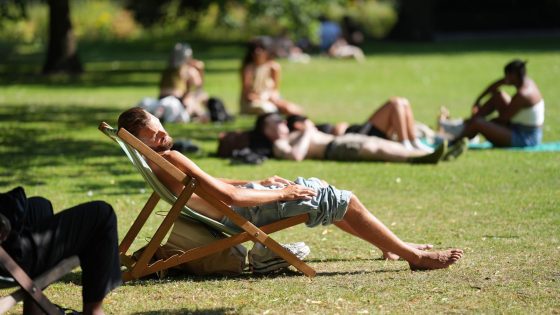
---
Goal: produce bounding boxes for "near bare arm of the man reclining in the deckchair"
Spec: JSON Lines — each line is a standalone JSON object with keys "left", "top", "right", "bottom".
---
{"left": 158, "top": 151, "right": 315, "bottom": 207}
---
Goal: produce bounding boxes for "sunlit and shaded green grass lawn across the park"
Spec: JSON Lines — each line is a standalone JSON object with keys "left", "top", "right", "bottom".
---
{"left": 0, "top": 39, "right": 560, "bottom": 314}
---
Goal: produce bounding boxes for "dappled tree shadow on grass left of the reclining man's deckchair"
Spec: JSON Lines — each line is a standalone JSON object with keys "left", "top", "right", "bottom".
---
{"left": 0, "top": 104, "right": 149, "bottom": 194}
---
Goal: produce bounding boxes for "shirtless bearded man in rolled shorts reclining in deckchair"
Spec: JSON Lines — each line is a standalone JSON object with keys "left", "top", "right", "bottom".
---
{"left": 118, "top": 108, "right": 463, "bottom": 270}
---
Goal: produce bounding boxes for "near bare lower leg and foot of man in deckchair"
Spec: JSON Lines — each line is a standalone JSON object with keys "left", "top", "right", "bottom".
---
{"left": 336, "top": 196, "right": 463, "bottom": 270}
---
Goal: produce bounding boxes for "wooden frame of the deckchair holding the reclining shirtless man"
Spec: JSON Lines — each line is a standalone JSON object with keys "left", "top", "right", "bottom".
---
{"left": 99, "top": 122, "right": 315, "bottom": 281}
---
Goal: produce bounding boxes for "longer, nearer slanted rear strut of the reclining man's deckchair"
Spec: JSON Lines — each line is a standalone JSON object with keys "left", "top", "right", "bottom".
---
{"left": 123, "top": 178, "right": 196, "bottom": 281}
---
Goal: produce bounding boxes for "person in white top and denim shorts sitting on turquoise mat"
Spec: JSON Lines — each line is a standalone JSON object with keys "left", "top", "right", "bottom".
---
{"left": 452, "top": 59, "right": 544, "bottom": 147}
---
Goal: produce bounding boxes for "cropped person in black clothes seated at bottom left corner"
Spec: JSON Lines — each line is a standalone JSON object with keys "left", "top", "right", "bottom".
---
{"left": 0, "top": 187, "right": 122, "bottom": 315}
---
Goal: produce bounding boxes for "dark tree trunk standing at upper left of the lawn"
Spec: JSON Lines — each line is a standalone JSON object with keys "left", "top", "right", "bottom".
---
{"left": 43, "top": 0, "right": 84, "bottom": 74}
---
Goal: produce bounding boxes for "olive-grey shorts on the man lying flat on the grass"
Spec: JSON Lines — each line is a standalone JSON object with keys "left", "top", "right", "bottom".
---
{"left": 325, "top": 133, "right": 370, "bottom": 161}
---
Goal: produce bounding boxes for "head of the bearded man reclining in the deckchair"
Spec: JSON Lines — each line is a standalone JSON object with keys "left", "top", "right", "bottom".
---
{"left": 118, "top": 107, "right": 173, "bottom": 152}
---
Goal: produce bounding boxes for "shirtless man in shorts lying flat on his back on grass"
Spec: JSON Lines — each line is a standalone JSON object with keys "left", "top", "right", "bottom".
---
{"left": 251, "top": 114, "right": 466, "bottom": 164}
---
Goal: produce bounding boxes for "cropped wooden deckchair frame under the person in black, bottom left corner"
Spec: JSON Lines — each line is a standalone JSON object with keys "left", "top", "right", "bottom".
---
{"left": 0, "top": 214, "right": 80, "bottom": 315}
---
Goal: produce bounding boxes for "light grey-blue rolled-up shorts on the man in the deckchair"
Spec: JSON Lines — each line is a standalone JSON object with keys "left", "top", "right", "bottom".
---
{"left": 222, "top": 177, "right": 352, "bottom": 231}
